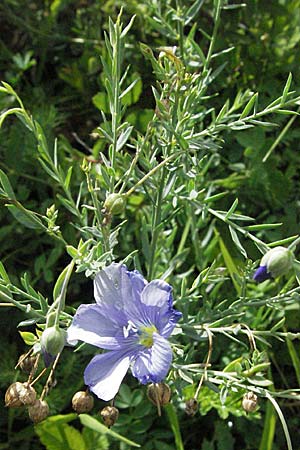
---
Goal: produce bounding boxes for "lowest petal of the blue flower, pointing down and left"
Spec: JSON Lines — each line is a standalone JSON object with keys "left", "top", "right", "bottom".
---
{"left": 84, "top": 351, "right": 132, "bottom": 401}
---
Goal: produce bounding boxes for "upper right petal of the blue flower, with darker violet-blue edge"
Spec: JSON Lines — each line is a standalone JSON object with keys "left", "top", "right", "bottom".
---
{"left": 141, "top": 280, "right": 182, "bottom": 337}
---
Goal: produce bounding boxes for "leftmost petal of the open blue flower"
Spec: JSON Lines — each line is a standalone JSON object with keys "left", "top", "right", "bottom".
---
{"left": 67, "top": 305, "right": 124, "bottom": 350}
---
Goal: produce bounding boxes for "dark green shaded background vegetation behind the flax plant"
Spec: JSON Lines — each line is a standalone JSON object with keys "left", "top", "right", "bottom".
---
{"left": 0, "top": 0, "right": 300, "bottom": 450}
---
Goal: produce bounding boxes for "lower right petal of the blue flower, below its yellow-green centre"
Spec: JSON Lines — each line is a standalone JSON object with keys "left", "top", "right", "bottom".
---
{"left": 131, "top": 333, "right": 172, "bottom": 384}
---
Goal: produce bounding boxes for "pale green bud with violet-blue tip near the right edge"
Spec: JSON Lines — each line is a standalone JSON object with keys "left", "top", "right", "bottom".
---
{"left": 253, "top": 246, "right": 294, "bottom": 283}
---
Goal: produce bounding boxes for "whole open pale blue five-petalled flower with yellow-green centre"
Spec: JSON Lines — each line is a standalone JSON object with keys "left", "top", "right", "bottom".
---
{"left": 68, "top": 263, "right": 181, "bottom": 401}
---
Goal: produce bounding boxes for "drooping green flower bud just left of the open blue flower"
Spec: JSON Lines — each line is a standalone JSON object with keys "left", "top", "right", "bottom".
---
{"left": 41, "top": 326, "right": 66, "bottom": 367}
